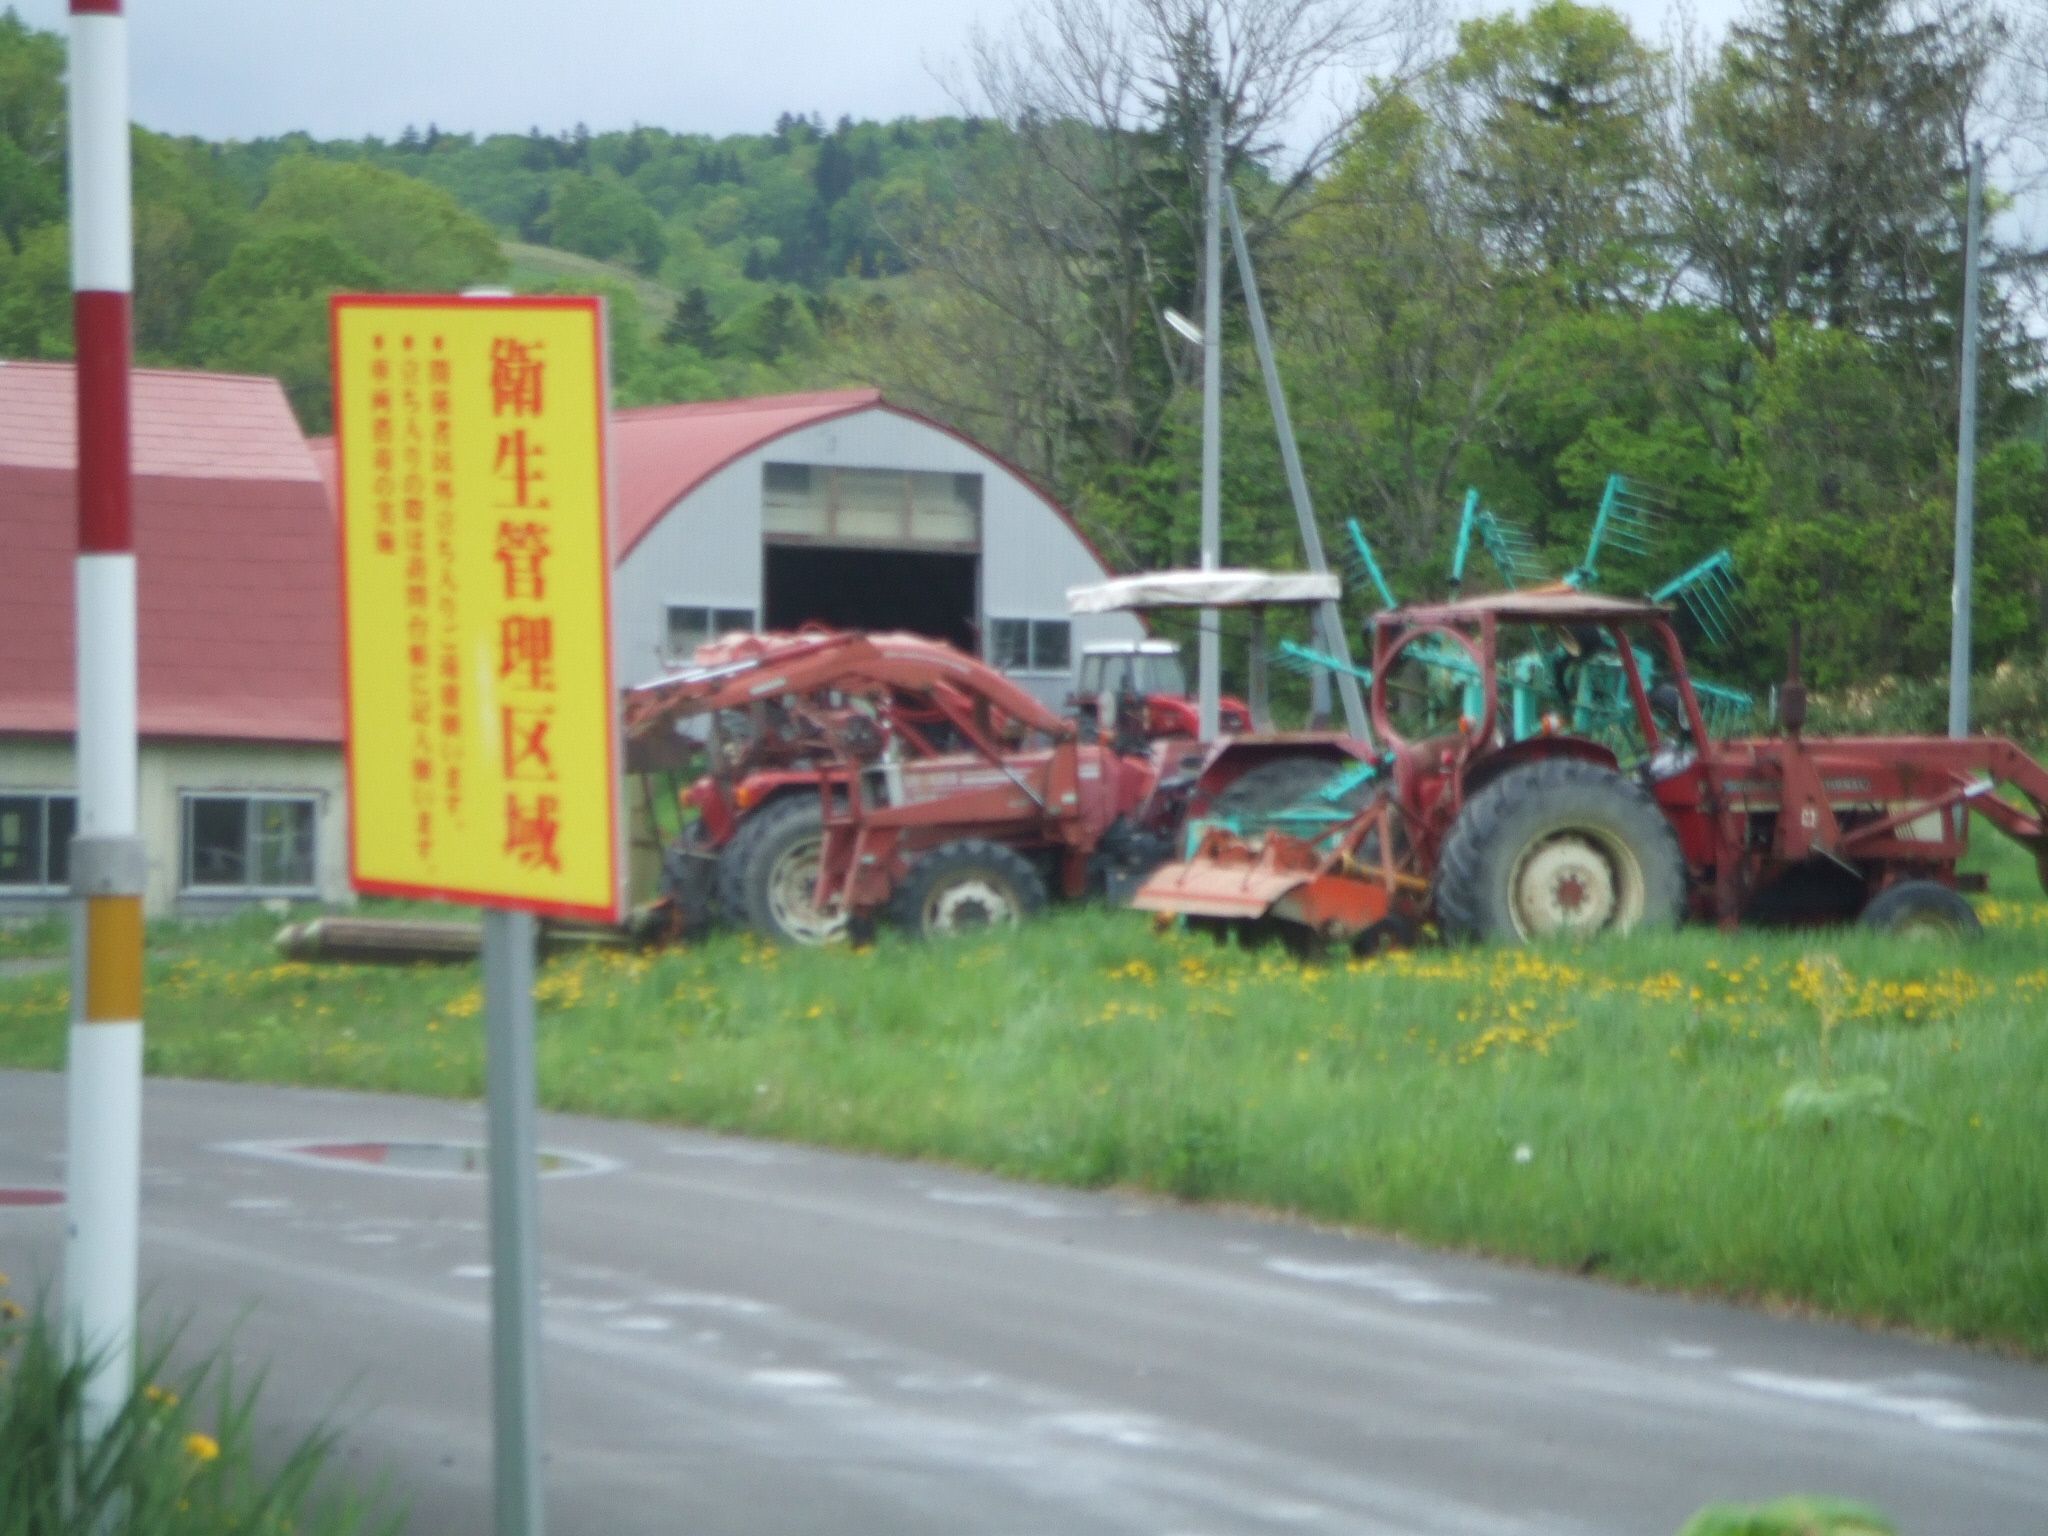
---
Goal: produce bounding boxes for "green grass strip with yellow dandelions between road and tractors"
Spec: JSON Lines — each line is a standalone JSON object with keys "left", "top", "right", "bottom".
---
{"left": 0, "top": 858, "right": 2048, "bottom": 1356}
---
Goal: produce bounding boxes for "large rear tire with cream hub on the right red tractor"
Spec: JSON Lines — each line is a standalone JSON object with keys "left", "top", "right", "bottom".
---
{"left": 1436, "top": 758, "right": 1686, "bottom": 942}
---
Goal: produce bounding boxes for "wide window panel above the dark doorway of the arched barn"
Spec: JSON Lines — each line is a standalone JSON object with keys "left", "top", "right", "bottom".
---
{"left": 762, "top": 463, "right": 981, "bottom": 549}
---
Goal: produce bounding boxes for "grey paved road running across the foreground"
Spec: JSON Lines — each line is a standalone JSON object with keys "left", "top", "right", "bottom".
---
{"left": 0, "top": 1073, "right": 2048, "bottom": 1536}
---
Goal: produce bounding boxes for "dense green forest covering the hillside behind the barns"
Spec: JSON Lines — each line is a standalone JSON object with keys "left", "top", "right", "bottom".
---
{"left": 0, "top": 0, "right": 2048, "bottom": 686}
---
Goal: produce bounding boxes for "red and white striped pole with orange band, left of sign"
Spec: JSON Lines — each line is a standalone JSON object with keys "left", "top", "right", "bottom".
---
{"left": 63, "top": 0, "right": 145, "bottom": 1438}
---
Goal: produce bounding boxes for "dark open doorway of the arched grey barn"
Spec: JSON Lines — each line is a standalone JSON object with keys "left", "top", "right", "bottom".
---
{"left": 762, "top": 545, "right": 981, "bottom": 655}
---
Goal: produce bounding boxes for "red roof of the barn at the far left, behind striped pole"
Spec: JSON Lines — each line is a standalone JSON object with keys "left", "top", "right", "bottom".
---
{"left": 0, "top": 362, "right": 342, "bottom": 743}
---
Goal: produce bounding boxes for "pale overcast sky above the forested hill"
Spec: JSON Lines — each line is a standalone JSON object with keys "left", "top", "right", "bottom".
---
{"left": 14, "top": 0, "right": 1739, "bottom": 139}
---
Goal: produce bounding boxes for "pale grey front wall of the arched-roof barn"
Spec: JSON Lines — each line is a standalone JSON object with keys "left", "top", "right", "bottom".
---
{"left": 612, "top": 408, "right": 1143, "bottom": 705}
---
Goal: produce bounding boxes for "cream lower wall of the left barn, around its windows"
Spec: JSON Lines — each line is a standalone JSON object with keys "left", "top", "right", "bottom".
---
{"left": 0, "top": 739, "right": 354, "bottom": 920}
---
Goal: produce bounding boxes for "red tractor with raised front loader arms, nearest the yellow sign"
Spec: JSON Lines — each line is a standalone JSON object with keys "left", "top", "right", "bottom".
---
{"left": 627, "top": 631, "right": 1186, "bottom": 944}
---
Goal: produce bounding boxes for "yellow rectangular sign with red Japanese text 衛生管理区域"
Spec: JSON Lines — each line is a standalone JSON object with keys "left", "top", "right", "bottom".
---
{"left": 334, "top": 295, "right": 621, "bottom": 920}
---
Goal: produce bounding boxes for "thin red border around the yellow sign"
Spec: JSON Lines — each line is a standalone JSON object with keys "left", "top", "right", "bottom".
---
{"left": 328, "top": 293, "right": 625, "bottom": 924}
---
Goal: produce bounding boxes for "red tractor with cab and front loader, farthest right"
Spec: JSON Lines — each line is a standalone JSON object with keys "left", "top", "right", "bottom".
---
{"left": 1135, "top": 590, "right": 2048, "bottom": 950}
